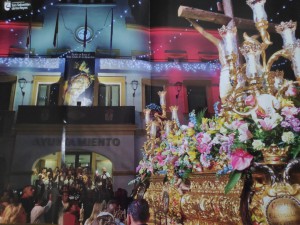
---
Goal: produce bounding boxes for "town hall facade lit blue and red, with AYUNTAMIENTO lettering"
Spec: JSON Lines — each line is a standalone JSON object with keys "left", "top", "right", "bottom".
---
{"left": 0, "top": 1, "right": 220, "bottom": 191}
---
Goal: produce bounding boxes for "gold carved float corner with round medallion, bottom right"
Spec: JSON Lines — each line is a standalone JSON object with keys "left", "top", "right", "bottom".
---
{"left": 249, "top": 160, "right": 300, "bottom": 225}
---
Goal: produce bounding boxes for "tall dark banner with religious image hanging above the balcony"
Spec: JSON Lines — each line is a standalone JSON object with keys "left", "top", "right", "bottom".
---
{"left": 63, "top": 52, "right": 95, "bottom": 106}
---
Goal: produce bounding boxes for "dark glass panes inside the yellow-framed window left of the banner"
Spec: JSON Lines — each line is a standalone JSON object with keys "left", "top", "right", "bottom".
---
{"left": 36, "top": 83, "right": 59, "bottom": 105}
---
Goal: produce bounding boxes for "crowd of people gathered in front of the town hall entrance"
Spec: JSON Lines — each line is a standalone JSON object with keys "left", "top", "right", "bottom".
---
{"left": 0, "top": 164, "right": 149, "bottom": 225}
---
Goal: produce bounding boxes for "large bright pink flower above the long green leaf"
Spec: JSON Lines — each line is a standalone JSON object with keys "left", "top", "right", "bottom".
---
{"left": 231, "top": 148, "right": 253, "bottom": 170}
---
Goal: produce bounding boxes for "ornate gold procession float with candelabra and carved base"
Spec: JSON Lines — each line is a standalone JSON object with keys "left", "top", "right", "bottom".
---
{"left": 139, "top": 0, "right": 300, "bottom": 225}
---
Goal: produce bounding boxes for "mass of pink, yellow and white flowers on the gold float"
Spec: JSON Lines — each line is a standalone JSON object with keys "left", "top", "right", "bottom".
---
{"left": 137, "top": 81, "right": 300, "bottom": 193}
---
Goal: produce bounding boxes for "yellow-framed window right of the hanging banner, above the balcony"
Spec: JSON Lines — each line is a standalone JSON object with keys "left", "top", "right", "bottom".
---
{"left": 95, "top": 74, "right": 126, "bottom": 106}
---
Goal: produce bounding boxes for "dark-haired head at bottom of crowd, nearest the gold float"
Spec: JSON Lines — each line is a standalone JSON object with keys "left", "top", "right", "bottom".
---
{"left": 127, "top": 199, "right": 150, "bottom": 225}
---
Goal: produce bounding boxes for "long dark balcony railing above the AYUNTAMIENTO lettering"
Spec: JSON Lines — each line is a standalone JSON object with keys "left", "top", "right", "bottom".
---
{"left": 17, "top": 106, "right": 135, "bottom": 124}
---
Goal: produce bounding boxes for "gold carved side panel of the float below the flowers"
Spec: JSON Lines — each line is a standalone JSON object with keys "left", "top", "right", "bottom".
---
{"left": 145, "top": 173, "right": 243, "bottom": 225}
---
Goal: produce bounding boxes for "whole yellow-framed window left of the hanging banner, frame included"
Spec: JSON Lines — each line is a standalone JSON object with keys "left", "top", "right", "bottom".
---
{"left": 31, "top": 76, "right": 62, "bottom": 106}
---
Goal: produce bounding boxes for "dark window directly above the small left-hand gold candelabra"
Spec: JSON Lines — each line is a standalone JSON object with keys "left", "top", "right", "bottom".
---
{"left": 142, "top": 79, "right": 167, "bottom": 108}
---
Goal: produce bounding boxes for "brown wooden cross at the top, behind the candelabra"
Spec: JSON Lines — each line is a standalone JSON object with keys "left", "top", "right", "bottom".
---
{"left": 178, "top": 0, "right": 275, "bottom": 32}
